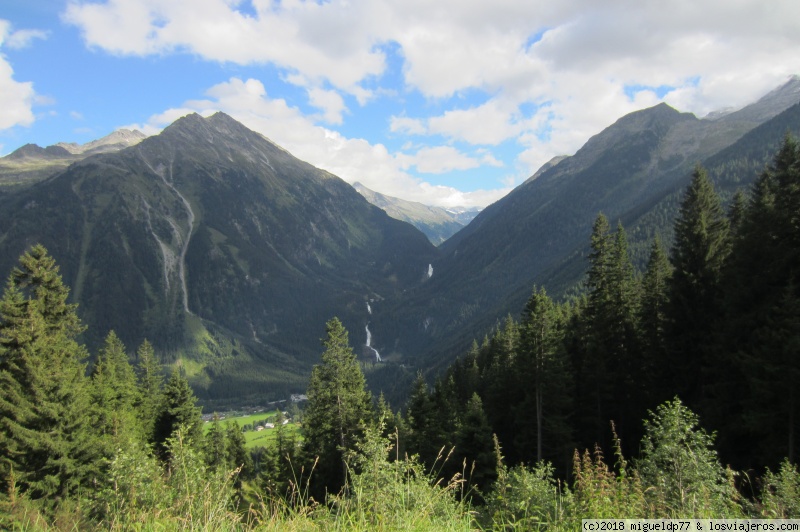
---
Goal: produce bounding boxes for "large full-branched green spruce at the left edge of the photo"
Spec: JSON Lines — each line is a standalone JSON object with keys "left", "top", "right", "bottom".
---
{"left": 0, "top": 245, "right": 97, "bottom": 502}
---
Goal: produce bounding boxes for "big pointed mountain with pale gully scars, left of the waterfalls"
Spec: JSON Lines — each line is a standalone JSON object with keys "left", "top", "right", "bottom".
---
{"left": 0, "top": 113, "right": 438, "bottom": 399}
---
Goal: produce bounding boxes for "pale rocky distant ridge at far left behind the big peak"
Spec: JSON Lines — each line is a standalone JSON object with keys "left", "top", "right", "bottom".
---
{"left": 0, "top": 129, "right": 145, "bottom": 195}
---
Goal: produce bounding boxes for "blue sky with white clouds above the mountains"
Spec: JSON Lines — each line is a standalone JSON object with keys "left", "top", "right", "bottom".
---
{"left": 0, "top": 0, "right": 800, "bottom": 207}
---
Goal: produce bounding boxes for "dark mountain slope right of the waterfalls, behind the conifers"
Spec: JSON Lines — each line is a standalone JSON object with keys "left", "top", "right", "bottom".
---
{"left": 374, "top": 78, "right": 800, "bottom": 368}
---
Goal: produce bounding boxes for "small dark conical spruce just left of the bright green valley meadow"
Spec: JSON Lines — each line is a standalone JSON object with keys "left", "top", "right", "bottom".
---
{"left": 153, "top": 369, "right": 203, "bottom": 460}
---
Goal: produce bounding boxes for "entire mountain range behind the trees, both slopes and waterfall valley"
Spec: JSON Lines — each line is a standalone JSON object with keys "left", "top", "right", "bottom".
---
{"left": 0, "top": 78, "right": 800, "bottom": 401}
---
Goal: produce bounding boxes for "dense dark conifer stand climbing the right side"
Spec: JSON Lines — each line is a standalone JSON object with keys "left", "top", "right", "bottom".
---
{"left": 406, "top": 136, "right": 800, "bottom": 486}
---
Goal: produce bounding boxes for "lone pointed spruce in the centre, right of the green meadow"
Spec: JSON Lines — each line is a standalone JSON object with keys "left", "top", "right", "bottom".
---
{"left": 304, "top": 318, "right": 372, "bottom": 495}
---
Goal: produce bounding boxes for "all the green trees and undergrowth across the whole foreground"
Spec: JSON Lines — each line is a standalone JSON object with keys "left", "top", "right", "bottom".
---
{"left": 0, "top": 136, "right": 800, "bottom": 530}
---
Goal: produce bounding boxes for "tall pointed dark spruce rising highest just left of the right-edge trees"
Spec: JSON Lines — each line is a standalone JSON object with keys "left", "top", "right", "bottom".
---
{"left": 666, "top": 166, "right": 730, "bottom": 404}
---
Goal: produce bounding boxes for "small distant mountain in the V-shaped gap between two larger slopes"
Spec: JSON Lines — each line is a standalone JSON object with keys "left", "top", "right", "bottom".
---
{"left": 353, "top": 183, "right": 480, "bottom": 246}
